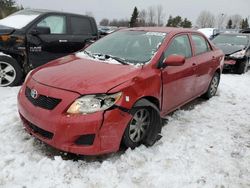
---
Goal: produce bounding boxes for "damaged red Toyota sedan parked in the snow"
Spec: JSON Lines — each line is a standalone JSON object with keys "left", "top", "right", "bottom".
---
{"left": 18, "top": 28, "right": 224, "bottom": 155}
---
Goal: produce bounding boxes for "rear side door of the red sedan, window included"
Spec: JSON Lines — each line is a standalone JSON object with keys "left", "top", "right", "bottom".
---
{"left": 191, "top": 34, "right": 218, "bottom": 95}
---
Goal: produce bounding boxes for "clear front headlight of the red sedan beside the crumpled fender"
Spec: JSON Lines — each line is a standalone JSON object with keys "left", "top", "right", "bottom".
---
{"left": 67, "top": 92, "right": 122, "bottom": 114}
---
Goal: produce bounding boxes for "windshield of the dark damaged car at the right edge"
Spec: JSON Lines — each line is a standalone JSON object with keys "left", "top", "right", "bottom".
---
{"left": 213, "top": 35, "right": 249, "bottom": 46}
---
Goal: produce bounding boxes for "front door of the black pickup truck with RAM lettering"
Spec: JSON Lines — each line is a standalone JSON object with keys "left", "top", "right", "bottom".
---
{"left": 27, "top": 14, "right": 72, "bottom": 68}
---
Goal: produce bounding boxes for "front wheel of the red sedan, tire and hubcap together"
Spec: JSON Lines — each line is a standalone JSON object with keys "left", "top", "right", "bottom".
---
{"left": 122, "top": 107, "right": 162, "bottom": 149}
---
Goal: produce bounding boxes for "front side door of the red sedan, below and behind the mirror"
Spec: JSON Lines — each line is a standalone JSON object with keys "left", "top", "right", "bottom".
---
{"left": 162, "top": 34, "right": 195, "bottom": 114}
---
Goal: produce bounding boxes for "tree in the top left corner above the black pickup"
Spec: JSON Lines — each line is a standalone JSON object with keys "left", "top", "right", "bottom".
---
{"left": 0, "top": 0, "right": 23, "bottom": 19}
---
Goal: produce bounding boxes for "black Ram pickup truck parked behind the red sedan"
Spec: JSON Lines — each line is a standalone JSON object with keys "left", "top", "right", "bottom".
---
{"left": 0, "top": 9, "right": 98, "bottom": 86}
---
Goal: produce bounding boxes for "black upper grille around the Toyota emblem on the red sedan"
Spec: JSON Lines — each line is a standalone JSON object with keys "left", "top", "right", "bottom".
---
{"left": 25, "top": 87, "right": 61, "bottom": 110}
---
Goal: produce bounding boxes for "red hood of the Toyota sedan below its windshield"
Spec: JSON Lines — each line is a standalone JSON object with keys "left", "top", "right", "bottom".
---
{"left": 32, "top": 55, "right": 141, "bottom": 94}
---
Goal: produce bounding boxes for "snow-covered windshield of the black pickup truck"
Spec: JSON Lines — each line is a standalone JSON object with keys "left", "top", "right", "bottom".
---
{"left": 0, "top": 11, "right": 39, "bottom": 29}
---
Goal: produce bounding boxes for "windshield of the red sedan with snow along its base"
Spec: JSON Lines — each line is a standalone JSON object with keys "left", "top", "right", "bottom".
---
{"left": 81, "top": 31, "right": 166, "bottom": 64}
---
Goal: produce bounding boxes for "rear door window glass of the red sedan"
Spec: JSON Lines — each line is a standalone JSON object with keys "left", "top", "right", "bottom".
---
{"left": 192, "top": 35, "right": 211, "bottom": 55}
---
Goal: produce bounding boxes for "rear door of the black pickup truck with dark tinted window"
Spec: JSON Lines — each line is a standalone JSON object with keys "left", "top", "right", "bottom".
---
{"left": 69, "top": 15, "right": 98, "bottom": 52}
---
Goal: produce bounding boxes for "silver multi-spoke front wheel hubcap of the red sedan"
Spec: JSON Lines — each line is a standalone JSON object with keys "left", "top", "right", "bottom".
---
{"left": 129, "top": 109, "right": 150, "bottom": 142}
